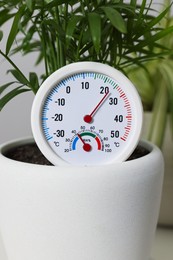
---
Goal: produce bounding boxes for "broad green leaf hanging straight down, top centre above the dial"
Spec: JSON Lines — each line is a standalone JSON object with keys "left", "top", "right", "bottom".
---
{"left": 88, "top": 13, "right": 101, "bottom": 53}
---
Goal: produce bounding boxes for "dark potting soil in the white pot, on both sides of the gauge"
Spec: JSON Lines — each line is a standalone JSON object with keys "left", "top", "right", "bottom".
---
{"left": 5, "top": 143, "right": 149, "bottom": 165}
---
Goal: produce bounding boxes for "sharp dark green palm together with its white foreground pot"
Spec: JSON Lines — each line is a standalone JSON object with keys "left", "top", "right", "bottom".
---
{"left": 0, "top": 0, "right": 173, "bottom": 260}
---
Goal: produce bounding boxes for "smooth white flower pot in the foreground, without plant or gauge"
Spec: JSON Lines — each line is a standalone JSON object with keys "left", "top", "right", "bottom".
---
{"left": 0, "top": 139, "right": 163, "bottom": 260}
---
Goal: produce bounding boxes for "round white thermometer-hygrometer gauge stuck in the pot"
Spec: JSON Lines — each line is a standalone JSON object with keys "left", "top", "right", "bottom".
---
{"left": 32, "top": 62, "right": 142, "bottom": 166}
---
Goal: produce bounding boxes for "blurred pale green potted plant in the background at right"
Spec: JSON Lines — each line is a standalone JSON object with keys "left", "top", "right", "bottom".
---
{"left": 128, "top": 1, "right": 173, "bottom": 225}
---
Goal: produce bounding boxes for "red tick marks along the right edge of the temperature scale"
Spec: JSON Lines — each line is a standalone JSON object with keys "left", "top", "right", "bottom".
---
{"left": 117, "top": 87, "right": 132, "bottom": 142}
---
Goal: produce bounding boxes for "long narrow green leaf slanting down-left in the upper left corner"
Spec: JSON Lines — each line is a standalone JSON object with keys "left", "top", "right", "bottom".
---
{"left": 6, "top": 6, "right": 25, "bottom": 55}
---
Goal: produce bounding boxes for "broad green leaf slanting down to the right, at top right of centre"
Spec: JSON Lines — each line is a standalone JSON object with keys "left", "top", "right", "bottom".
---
{"left": 101, "top": 6, "right": 127, "bottom": 33}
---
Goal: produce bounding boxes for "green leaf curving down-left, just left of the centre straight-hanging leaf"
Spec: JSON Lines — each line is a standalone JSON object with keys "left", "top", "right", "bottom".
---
{"left": 66, "top": 15, "right": 82, "bottom": 47}
